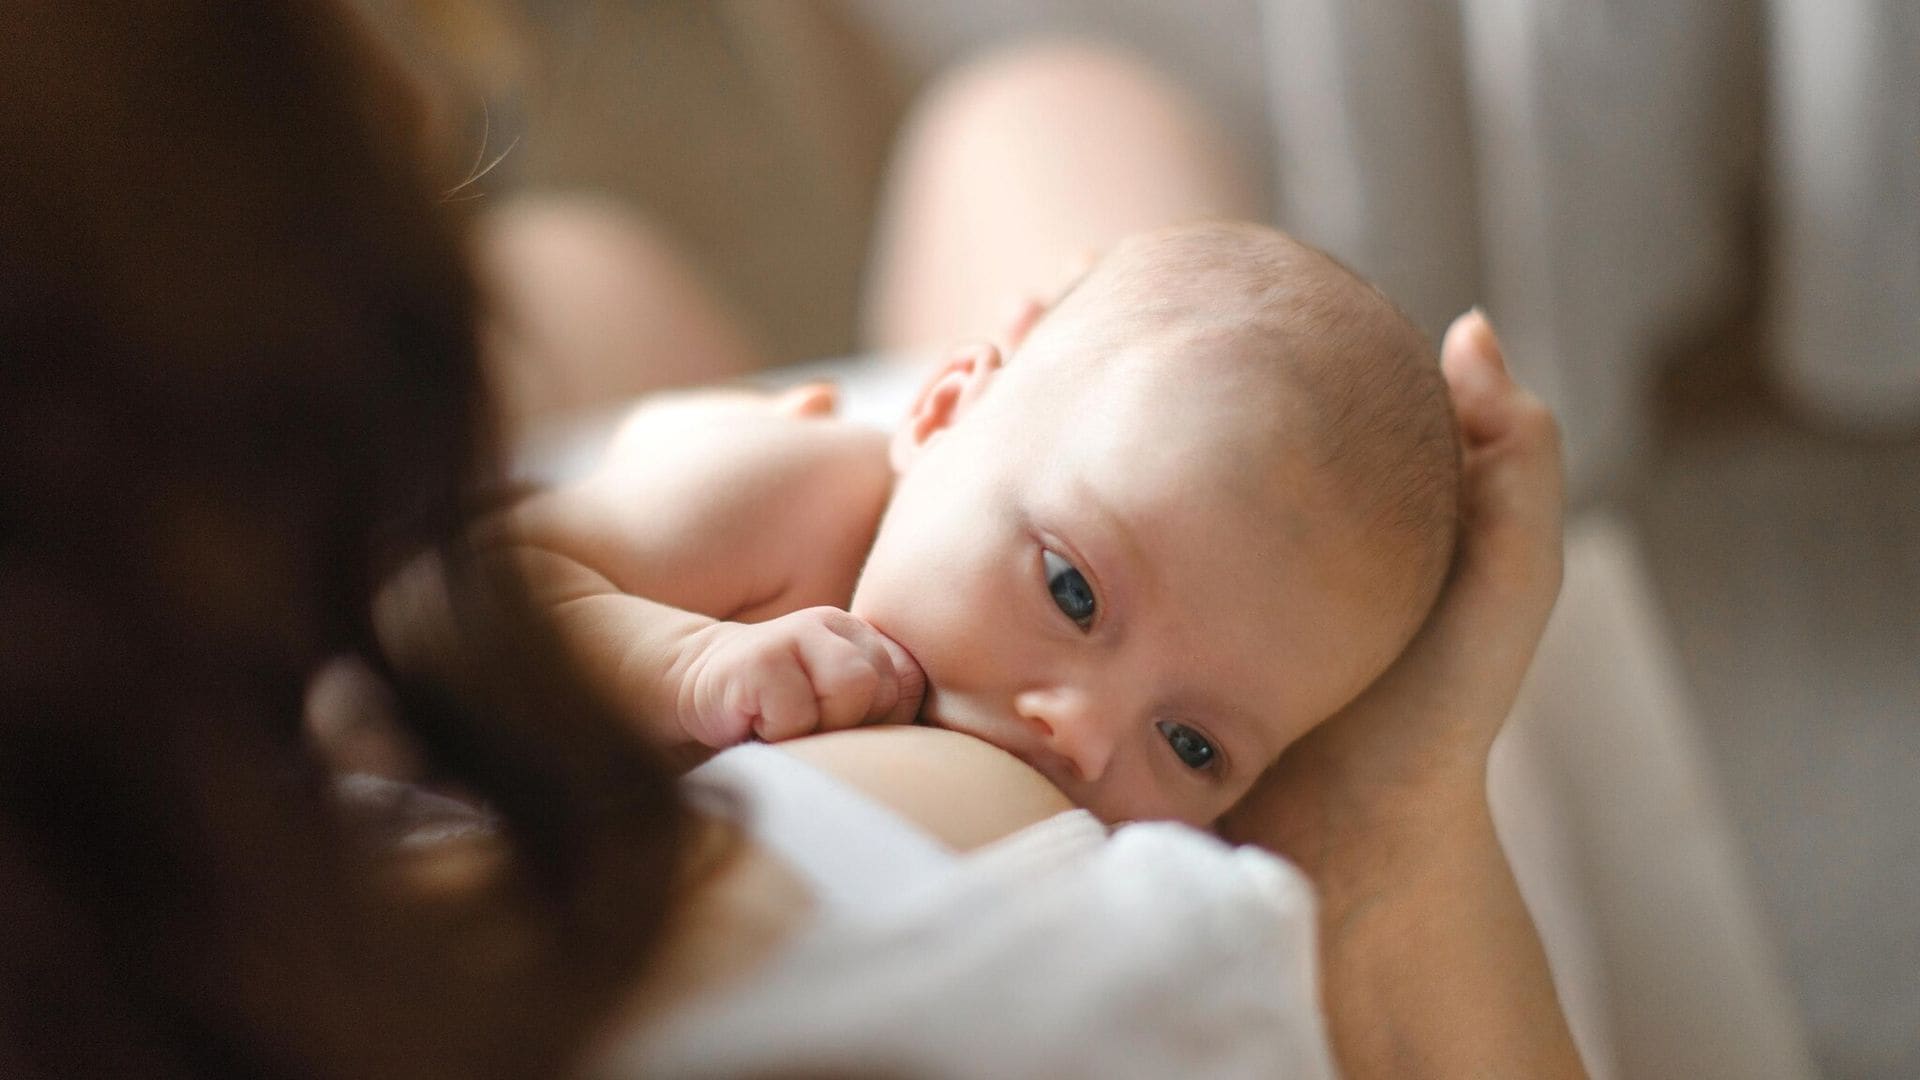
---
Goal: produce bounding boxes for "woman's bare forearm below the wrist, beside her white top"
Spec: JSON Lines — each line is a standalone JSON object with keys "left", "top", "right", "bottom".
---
{"left": 1288, "top": 790, "right": 1586, "bottom": 1080}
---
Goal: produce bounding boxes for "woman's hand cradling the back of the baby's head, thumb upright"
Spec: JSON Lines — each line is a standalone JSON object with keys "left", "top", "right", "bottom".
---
{"left": 1221, "top": 309, "right": 1561, "bottom": 853}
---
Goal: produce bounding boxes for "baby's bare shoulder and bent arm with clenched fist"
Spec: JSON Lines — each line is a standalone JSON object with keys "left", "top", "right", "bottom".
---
{"left": 382, "top": 386, "right": 920, "bottom": 746}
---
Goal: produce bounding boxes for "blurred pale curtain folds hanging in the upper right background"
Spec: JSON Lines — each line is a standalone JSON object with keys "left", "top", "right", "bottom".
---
{"left": 1259, "top": 0, "right": 1920, "bottom": 490}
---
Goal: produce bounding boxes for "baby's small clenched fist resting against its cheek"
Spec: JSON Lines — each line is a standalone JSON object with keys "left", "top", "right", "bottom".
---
{"left": 678, "top": 607, "right": 925, "bottom": 748}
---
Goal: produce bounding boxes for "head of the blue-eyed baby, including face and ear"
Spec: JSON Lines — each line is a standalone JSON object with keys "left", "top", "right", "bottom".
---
{"left": 852, "top": 225, "right": 1459, "bottom": 824}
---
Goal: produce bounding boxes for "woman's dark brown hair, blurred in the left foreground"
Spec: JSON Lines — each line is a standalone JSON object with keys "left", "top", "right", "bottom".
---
{"left": 0, "top": 0, "right": 684, "bottom": 1078}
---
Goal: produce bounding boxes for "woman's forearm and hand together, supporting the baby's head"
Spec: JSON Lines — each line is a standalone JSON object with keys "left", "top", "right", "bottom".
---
{"left": 1223, "top": 311, "right": 1584, "bottom": 1078}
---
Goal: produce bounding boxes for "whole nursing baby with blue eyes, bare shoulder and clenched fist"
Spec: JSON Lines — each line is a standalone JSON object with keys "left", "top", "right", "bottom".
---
{"left": 435, "top": 225, "right": 1459, "bottom": 824}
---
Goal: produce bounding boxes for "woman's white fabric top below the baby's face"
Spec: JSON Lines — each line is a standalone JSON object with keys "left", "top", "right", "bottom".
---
{"left": 601, "top": 746, "right": 1334, "bottom": 1078}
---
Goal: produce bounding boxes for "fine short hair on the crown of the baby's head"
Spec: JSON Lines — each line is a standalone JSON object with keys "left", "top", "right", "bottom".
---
{"left": 1016, "top": 221, "right": 1461, "bottom": 630}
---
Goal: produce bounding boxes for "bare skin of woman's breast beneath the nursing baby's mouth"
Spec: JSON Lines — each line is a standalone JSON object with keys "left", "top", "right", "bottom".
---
{"left": 780, "top": 724, "right": 1073, "bottom": 851}
